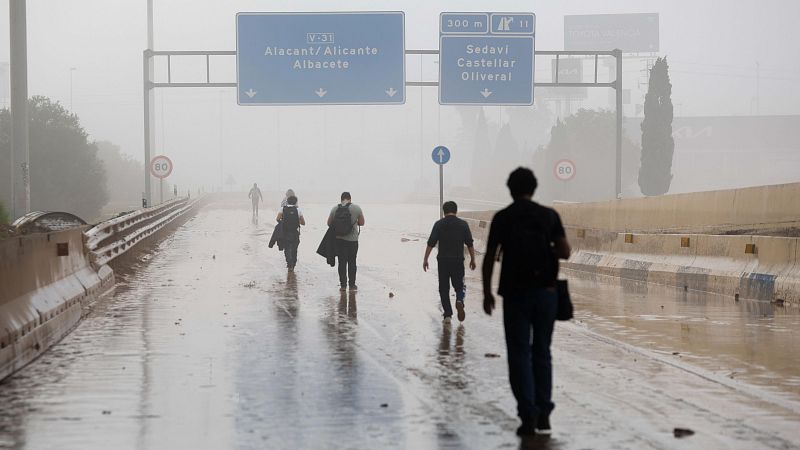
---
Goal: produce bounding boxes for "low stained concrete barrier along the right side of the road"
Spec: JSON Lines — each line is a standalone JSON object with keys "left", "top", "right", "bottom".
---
{"left": 562, "top": 227, "right": 800, "bottom": 303}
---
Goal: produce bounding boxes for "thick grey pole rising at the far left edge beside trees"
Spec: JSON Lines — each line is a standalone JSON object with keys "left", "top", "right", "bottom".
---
{"left": 8, "top": 0, "right": 31, "bottom": 219}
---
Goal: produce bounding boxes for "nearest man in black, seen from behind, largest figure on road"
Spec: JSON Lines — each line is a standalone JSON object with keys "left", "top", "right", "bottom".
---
{"left": 483, "top": 167, "right": 570, "bottom": 436}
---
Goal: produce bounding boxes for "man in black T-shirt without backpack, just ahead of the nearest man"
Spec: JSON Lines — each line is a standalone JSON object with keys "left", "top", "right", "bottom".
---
{"left": 422, "top": 202, "right": 475, "bottom": 323}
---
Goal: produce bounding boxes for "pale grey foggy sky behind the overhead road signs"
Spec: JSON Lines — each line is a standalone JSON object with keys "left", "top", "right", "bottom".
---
{"left": 0, "top": 0, "right": 800, "bottom": 197}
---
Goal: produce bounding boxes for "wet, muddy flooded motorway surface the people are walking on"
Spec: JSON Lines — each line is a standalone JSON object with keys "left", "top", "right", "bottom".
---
{"left": 0, "top": 199, "right": 800, "bottom": 449}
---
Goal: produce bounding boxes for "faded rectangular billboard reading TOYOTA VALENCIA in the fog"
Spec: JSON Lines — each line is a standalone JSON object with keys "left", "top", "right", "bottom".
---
{"left": 564, "top": 13, "right": 659, "bottom": 53}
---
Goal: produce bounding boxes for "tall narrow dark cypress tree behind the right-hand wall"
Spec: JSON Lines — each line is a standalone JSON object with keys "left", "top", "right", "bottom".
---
{"left": 639, "top": 57, "right": 675, "bottom": 195}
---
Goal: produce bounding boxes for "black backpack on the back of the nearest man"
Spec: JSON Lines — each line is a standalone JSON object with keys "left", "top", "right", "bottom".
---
{"left": 503, "top": 207, "right": 558, "bottom": 287}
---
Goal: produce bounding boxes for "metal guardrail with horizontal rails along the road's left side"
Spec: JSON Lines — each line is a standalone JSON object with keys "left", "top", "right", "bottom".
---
{"left": 85, "top": 197, "right": 198, "bottom": 266}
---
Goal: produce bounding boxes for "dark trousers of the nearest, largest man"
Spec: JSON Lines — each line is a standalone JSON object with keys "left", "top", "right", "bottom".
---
{"left": 503, "top": 288, "right": 558, "bottom": 420}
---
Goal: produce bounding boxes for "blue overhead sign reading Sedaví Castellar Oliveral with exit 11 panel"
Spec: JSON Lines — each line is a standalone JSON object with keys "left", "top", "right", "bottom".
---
{"left": 439, "top": 13, "right": 536, "bottom": 105}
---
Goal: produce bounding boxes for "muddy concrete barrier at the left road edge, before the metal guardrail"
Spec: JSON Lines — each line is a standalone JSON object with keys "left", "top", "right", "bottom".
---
{"left": 0, "top": 227, "right": 114, "bottom": 380}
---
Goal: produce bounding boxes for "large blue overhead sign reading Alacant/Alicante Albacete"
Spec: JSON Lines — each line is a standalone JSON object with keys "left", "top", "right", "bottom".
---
{"left": 236, "top": 12, "right": 406, "bottom": 105}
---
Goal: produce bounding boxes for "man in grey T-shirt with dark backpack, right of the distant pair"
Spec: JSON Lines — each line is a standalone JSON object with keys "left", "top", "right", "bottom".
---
{"left": 328, "top": 192, "right": 364, "bottom": 291}
